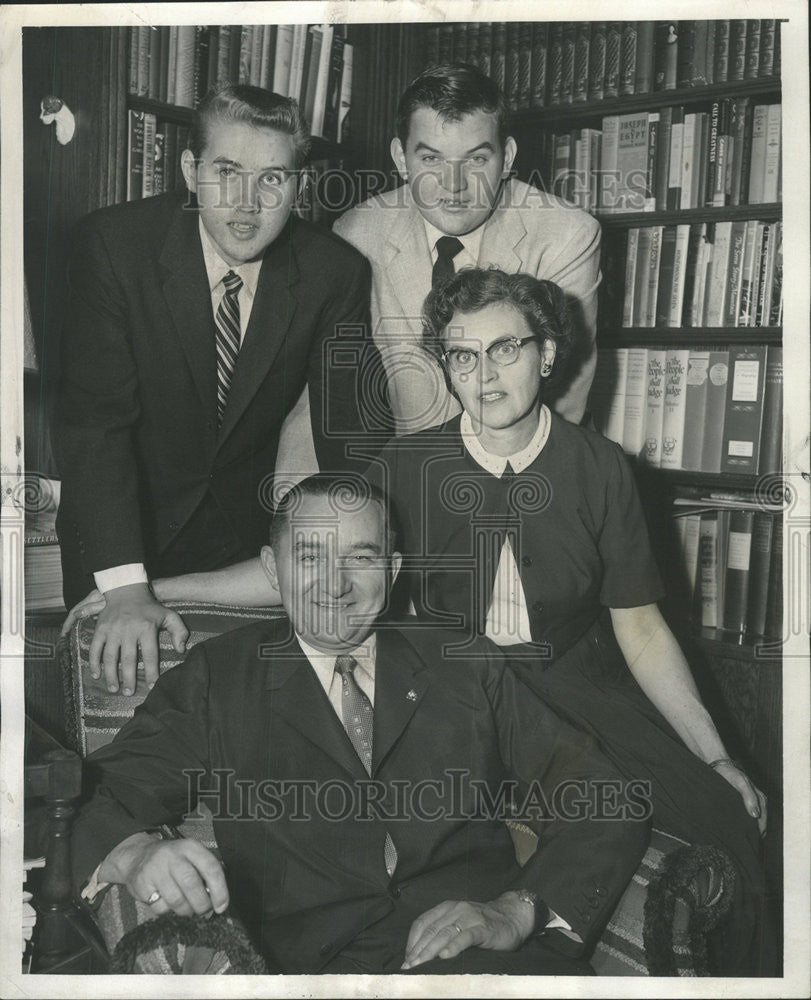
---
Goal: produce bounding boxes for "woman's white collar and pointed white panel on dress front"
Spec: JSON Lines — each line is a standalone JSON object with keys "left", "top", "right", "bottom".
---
{"left": 459, "top": 406, "right": 550, "bottom": 646}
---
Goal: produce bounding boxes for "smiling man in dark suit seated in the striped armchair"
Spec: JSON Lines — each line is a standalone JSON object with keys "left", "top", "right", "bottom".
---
{"left": 73, "top": 475, "right": 647, "bottom": 974}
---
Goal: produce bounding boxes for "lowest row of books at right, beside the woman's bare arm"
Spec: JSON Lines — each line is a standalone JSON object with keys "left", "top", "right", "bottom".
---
{"left": 674, "top": 503, "right": 783, "bottom": 638}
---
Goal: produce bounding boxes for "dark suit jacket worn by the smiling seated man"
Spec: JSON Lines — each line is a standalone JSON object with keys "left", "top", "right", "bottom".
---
{"left": 73, "top": 623, "right": 646, "bottom": 972}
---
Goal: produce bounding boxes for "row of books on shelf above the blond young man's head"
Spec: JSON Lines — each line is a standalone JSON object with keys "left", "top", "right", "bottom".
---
{"left": 128, "top": 24, "right": 353, "bottom": 142}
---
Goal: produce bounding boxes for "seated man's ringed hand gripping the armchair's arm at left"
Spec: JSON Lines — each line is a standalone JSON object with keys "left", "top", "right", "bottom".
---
{"left": 99, "top": 833, "right": 229, "bottom": 917}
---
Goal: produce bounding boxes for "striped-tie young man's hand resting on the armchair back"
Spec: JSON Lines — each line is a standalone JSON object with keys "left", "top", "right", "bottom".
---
{"left": 90, "top": 583, "right": 189, "bottom": 694}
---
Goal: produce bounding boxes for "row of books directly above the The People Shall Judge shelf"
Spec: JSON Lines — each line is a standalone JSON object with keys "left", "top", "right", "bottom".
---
{"left": 622, "top": 220, "right": 783, "bottom": 327}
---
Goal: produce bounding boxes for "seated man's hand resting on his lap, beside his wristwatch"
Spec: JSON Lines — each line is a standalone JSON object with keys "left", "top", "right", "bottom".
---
{"left": 401, "top": 892, "right": 535, "bottom": 969}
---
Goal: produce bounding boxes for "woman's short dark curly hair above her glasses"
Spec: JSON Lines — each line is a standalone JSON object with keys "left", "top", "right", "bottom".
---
{"left": 422, "top": 267, "right": 574, "bottom": 396}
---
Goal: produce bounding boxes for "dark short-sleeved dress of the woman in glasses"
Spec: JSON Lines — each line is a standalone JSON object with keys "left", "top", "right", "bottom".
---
{"left": 370, "top": 414, "right": 763, "bottom": 971}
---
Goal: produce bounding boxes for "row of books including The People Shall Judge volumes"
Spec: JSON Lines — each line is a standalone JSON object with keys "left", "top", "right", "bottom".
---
{"left": 589, "top": 345, "right": 783, "bottom": 475}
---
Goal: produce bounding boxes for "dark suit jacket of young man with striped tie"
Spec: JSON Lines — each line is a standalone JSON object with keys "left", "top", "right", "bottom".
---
{"left": 55, "top": 194, "right": 390, "bottom": 600}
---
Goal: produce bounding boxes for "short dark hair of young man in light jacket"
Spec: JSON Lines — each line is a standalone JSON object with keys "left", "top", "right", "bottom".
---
{"left": 397, "top": 63, "right": 510, "bottom": 149}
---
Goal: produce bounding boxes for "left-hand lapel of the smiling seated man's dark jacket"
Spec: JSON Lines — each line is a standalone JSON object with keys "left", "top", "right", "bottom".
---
{"left": 267, "top": 638, "right": 366, "bottom": 778}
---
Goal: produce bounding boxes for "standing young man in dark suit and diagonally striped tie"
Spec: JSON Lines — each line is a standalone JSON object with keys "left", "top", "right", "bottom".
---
{"left": 55, "top": 86, "right": 385, "bottom": 686}
